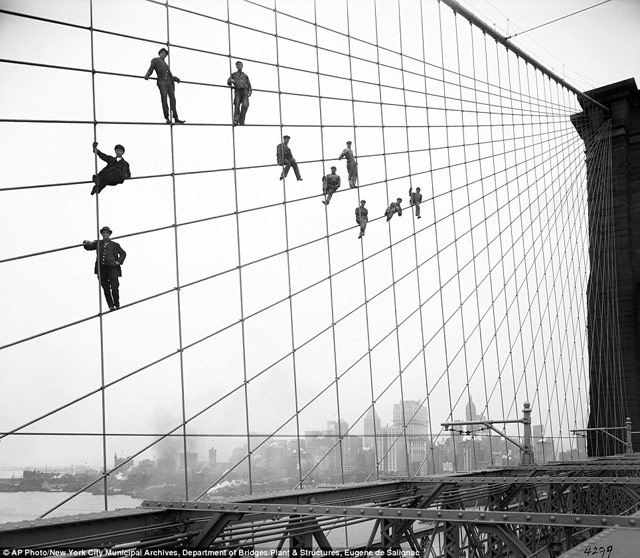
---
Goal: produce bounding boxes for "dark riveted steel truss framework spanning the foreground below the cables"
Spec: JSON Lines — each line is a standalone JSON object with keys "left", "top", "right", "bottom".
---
{"left": 0, "top": 455, "right": 640, "bottom": 558}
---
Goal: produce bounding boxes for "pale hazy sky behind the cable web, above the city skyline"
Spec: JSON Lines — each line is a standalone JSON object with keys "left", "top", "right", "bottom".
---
{"left": 0, "top": 0, "right": 640, "bottom": 508}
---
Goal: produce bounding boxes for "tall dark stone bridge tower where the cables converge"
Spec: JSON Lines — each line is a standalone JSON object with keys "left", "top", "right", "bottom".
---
{"left": 571, "top": 79, "right": 640, "bottom": 456}
